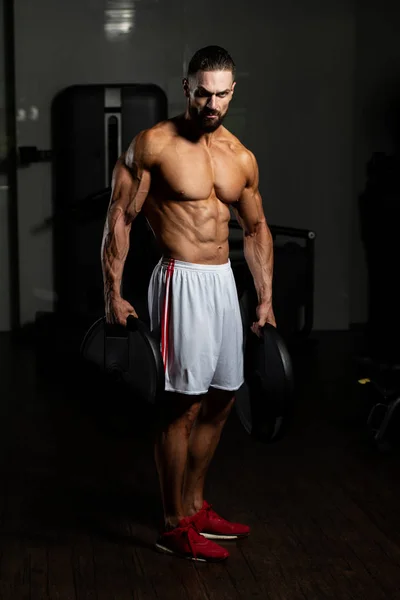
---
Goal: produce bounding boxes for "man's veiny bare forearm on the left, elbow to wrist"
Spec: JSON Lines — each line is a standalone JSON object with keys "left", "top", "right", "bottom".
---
{"left": 101, "top": 210, "right": 131, "bottom": 305}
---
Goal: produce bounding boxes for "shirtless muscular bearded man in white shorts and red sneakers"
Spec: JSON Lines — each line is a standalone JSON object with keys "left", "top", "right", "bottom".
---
{"left": 101, "top": 46, "right": 276, "bottom": 561}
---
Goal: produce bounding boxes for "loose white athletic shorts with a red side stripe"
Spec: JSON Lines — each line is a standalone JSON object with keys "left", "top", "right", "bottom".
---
{"left": 148, "top": 259, "right": 244, "bottom": 394}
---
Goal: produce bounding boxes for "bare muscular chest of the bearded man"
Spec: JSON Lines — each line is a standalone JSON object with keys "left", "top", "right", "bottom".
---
{"left": 154, "top": 145, "right": 245, "bottom": 203}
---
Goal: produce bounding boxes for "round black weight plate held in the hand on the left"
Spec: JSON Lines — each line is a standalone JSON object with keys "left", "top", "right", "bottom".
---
{"left": 80, "top": 315, "right": 165, "bottom": 404}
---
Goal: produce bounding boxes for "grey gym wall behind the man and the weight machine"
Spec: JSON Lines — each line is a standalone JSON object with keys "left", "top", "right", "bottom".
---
{"left": 9, "top": 0, "right": 355, "bottom": 329}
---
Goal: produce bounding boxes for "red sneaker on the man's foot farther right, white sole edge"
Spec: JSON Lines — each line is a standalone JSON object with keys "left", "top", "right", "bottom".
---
{"left": 190, "top": 500, "right": 250, "bottom": 540}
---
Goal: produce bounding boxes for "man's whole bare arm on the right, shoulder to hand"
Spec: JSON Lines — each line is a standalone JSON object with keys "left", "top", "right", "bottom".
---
{"left": 233, "top": 151, "right": 276, "bottom": 335}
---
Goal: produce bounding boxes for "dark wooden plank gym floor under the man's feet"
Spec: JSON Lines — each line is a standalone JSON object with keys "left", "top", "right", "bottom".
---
{"left": 0, "top": 332, "right": 400, "bottom": 600}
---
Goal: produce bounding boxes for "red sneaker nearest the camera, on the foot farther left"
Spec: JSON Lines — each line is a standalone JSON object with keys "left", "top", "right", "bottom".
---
{"left": 155, "top": 517, "right": 229, "bottom": 562}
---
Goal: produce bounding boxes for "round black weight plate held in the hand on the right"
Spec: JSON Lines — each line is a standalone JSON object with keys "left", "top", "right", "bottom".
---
{"left": 235, "top": 290, "right": 294, "bottom": 442}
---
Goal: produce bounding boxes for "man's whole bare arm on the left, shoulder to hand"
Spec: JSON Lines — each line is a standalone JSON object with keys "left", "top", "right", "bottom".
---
{"left": 101, "top": 131, "right": 152, "bottom": 325}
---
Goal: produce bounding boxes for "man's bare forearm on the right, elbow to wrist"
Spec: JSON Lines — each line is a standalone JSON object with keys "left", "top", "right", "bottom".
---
{"left": 244, "top": 220, "right": 274, "bottom": 306}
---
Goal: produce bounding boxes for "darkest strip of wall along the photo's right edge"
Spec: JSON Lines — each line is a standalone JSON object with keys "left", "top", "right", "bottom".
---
{"left": 350, "top": 0, "right": 400, "bottom": 323}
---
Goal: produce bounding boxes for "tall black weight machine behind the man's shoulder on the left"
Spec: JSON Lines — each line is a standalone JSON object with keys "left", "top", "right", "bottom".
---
{"left": 51, "top": 83, "right": 168, "bottom": 322}
